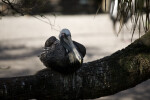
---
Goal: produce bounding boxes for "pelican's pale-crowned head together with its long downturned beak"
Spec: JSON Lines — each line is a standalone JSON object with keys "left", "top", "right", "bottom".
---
{"left": 59, "top": 29, "right": 82, "bottom": 63}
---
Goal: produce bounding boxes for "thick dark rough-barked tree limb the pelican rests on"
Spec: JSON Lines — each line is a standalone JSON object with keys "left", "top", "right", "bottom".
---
{"left": 0, "top": 32, "right": 150, "bottom": 100}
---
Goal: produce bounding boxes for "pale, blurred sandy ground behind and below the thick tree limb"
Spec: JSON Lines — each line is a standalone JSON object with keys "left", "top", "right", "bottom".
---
{"left": 0, "top": 14, "right": 150, "bottom": 100}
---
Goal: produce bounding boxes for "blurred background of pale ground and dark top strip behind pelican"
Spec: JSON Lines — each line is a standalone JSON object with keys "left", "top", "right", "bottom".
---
{"left": 0, "top": 0, "right": 150, "bottom": 100}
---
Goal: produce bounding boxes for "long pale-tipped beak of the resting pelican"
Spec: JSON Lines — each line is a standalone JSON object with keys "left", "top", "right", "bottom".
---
{"left": 64, "top": 36, "right": 82, "bottom": 63}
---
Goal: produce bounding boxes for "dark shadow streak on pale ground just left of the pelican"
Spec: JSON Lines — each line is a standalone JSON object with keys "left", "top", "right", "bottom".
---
{"left": 0, "top": 45, "right": 42, "bottom": 60}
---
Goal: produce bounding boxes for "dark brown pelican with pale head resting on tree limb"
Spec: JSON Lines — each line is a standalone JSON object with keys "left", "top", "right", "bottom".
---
{"left": 39, "top": 28, "right": 86, "bottom": 74}
